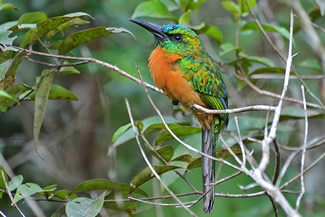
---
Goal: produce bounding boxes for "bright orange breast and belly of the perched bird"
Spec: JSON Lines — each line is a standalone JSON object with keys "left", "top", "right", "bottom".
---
{"left": 149, "top": 48, "right": 213, "bottom": 129}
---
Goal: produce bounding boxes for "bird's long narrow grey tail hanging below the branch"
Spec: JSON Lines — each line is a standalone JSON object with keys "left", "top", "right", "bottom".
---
{"left": 202, "top": 120, "right": 220, "bottom": 213}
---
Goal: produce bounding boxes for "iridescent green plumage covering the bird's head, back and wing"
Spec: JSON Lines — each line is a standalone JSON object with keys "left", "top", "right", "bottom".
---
{"left": 157, "top": 24, "right": 228, "bottom": 125}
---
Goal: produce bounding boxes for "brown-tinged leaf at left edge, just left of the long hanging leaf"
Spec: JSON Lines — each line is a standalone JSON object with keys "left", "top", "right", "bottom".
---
{"left": 0, "top": 51, "right": 26, "bottom": 89}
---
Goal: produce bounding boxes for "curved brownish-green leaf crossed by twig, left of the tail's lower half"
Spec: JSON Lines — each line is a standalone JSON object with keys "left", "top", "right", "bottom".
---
{"left": 129, "top": 165, "right": 180, "bottom": 193}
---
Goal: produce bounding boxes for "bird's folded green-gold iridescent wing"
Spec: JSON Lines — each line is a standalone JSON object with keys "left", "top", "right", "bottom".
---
{"left": 180, "top": 57, "right": 228, "bottom": 123}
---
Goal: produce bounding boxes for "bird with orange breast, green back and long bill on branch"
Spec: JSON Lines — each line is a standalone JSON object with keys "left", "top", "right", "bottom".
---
{"left": 130, "top": 19, "right": 228, "bottom": 213}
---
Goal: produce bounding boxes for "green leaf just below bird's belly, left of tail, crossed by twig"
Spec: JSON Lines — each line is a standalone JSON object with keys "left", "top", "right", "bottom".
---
{"left": 155, "top": 126, "right": 201, "bottom": 145}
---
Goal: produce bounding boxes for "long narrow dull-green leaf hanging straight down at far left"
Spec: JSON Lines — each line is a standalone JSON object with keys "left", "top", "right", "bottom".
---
{"left": 33, "top": 69, "right": 55, "bottom": 148}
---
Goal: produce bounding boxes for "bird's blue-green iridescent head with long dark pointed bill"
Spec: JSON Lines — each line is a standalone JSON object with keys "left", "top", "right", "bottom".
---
{"left": 130, "top": 19, "right": 205, "bottom": 56}
